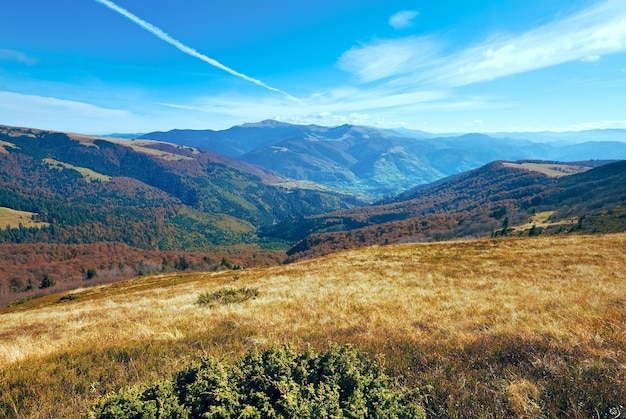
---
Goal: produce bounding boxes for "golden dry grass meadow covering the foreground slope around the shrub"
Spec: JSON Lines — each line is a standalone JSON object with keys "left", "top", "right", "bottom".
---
{"left": 0, "top": 234, "right": 626, "bottom": 418}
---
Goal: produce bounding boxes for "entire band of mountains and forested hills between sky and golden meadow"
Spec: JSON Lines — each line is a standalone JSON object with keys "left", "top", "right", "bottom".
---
{"left": 0, "top": 121, "right": 626, "bottom": 301}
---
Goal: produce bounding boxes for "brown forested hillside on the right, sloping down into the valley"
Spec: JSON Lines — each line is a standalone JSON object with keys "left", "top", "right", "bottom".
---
{"left": 274, "top": 161, "right": 626, "bottom": 260}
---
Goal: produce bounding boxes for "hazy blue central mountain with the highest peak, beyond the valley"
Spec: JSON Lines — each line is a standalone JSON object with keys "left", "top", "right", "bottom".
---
{"left": 141, "top": 120, "right": 445, "bottom": 199}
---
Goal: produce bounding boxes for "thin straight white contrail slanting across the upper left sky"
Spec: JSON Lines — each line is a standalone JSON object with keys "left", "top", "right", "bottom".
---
{"left": 96, "top": 0, "right": 300, "bottom": 102}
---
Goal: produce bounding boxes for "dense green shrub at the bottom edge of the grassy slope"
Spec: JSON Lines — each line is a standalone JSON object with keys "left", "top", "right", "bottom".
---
{"left": 93, "top": 346, "right": 423, "bottom": 419}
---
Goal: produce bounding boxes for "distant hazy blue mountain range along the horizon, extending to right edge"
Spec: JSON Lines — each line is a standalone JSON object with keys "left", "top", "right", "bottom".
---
{"left": 140, "top": 120, "right": 626, "bottom": 201}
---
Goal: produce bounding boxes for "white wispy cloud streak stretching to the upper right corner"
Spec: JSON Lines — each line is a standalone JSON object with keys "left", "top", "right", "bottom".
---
{"left": 339, "top": 0, "right": 626, "bottom": 87}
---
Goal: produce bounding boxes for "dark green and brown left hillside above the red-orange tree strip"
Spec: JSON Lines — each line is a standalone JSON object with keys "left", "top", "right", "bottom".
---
{"left": 0, "top": 127, "right": 358, "bottom": 249}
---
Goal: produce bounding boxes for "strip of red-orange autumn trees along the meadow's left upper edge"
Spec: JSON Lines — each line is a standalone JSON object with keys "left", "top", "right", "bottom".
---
{"left": 0, "top": 243, "right": 285, "bottom": 305}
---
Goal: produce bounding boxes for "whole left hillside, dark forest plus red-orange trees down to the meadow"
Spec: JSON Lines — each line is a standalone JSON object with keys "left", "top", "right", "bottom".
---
{"left": 0, "top": 127, "right": 359, "bottom": 303}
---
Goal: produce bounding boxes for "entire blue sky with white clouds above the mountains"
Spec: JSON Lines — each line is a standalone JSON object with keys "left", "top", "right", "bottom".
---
{"left": 0, "top": 0, "right": 626, "bottom": 134}
